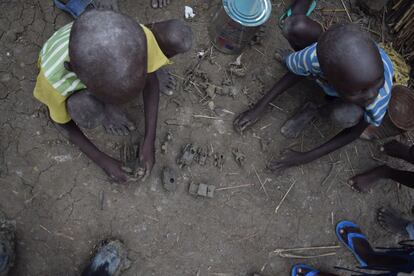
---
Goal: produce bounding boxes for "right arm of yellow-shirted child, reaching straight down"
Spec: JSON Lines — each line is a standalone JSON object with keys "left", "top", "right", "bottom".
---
{"left": 139, "top": 73, "right": 160, "bottom": 178}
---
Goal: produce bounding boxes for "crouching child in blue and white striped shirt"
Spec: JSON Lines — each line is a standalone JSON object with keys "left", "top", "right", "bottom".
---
{"left": 234, "top": 0, "right": 393, "bottom": 170}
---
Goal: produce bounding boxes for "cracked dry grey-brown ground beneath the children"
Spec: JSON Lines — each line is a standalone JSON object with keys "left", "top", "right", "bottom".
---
{"left": 0, "top": 0, "right": 412, "bottom": 275}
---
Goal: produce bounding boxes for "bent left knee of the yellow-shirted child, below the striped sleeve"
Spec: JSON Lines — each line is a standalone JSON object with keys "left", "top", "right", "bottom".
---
{"left": 66, "top": 91, "right": 105, "bottom": 129}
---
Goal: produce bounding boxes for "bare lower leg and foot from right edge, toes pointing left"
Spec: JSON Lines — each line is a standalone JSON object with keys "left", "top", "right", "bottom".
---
{"left": 349, "top": 165, "right": 414, "bottom": 192}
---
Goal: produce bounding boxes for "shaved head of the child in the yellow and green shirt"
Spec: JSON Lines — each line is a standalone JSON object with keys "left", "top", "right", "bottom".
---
{"left": 69, "top": 10, "right": 147, "bottom": 104}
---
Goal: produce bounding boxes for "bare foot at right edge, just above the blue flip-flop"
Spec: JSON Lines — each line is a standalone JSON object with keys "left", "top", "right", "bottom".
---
{"left": 377, "top": 207, "right": 410, "bottom": 236}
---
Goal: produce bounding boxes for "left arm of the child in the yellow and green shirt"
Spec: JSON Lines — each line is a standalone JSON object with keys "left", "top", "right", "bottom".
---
{"left": 56, "top": 121, "right": 128, "bottom": 182}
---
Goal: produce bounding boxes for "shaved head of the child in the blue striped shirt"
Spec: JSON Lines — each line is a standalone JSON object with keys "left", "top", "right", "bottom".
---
{"left": 317, "top": 24, "right": 384, "bottom": 106}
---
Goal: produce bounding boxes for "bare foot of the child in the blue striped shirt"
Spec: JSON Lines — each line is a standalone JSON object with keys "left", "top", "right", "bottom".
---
{"left": 280, "top": 102, "right": 318, "bottom": 138}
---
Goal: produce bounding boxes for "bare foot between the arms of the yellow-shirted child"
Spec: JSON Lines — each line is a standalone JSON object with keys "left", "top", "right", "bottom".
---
{"left": 102, "top": 104, "right": 135, "bottom": 136}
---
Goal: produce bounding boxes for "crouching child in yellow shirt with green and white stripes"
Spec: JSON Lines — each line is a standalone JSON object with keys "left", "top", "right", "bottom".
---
{"left": 34, "top": 10, "right": 192, "bottom": 182}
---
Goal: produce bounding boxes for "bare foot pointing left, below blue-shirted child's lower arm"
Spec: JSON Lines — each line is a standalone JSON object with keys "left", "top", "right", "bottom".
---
{"left": 348, "top": 165, "right": 389, "bottom": 193}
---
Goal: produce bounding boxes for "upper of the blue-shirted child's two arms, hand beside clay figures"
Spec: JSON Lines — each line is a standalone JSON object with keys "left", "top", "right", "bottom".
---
{"left": 234, "top": 72, "right": 305, "bottom": 132}
